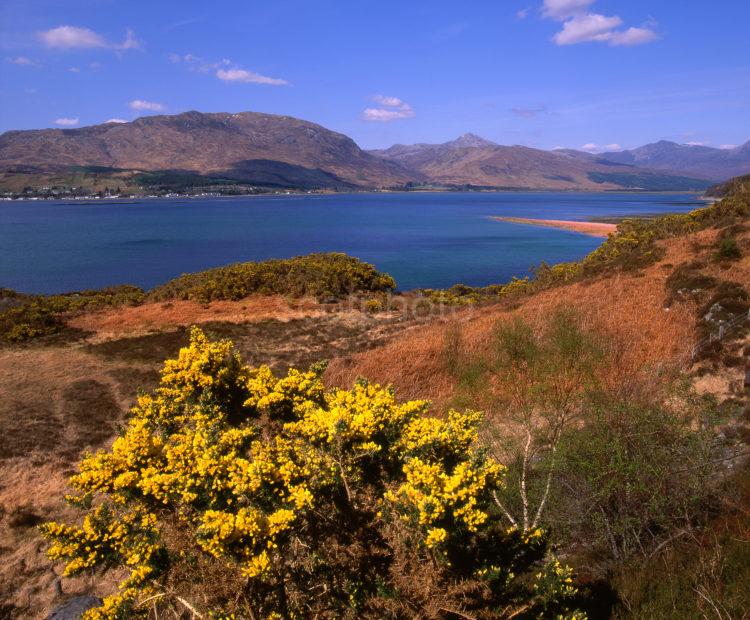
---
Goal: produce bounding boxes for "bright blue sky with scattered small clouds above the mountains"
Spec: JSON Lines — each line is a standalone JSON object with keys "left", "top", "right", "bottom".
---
{"left": 0, "top": 0, "right": 750, "bottom": 150}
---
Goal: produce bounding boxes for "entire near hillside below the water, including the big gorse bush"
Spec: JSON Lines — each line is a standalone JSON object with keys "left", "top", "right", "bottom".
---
{"left": 0, "top": 176, "right": 750, "bottom": 620}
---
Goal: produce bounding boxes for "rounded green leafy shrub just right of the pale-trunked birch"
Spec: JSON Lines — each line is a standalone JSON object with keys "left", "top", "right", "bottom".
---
{"left": 547, "top": 401, "right": 715, "bottom": 572}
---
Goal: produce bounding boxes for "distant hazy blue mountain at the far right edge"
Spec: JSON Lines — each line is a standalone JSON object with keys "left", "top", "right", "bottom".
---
{"left": 600, "top": 140, "right": 750, "bottom": 181}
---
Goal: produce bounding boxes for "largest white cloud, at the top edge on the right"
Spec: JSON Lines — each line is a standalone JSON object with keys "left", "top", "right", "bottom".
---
{"left": 542, "top": 0, "right": 658, "bottom": 46}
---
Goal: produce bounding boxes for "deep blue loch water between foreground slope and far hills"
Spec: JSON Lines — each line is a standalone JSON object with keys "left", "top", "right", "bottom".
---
{"left": 0, "top": 192, "right": 703, "bottom": 293}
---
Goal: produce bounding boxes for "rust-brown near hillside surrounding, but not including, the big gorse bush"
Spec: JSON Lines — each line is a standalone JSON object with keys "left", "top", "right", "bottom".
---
{"left": 0, "top": 180, "right": 750, "bottom": 620}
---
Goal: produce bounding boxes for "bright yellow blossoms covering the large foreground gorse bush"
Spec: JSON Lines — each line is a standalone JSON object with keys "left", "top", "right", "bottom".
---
{"left": 42, "top": 329, "right": 588, "bottom": 618}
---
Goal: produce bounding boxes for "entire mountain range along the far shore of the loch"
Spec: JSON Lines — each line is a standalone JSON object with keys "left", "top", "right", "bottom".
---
{"left": 0, "top": 112, "right": 750, "bottom": 190}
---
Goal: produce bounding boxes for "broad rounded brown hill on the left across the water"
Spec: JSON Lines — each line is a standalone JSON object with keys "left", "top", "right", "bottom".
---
{"left": 0, "top": 112, "right": 419, "bottom": 188}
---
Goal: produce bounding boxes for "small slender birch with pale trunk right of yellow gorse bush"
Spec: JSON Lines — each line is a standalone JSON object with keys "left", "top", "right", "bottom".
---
{"left": 446, "top": 310, "right": 607, "bottom": 532}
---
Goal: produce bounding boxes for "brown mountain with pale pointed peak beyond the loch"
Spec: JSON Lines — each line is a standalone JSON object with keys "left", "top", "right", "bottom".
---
{"left": 370, "top": 134, "right": 708, "bottom": 190}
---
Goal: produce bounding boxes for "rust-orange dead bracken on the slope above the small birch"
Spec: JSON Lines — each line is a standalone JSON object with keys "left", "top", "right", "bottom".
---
{"left": 326, "top": 230, "right": 750, "bottom": 407}
